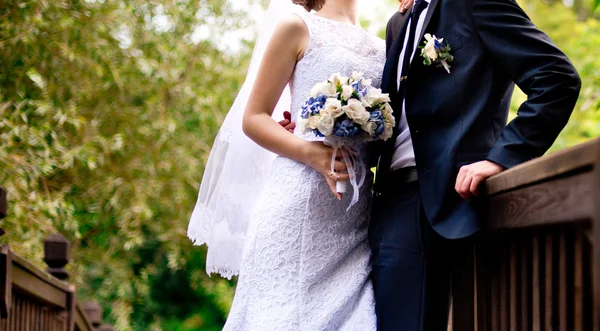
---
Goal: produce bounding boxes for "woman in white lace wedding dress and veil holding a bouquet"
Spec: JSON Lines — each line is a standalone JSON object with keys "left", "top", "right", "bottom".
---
{"left": 188, "top": 0, "right": 385, "bottom": 331}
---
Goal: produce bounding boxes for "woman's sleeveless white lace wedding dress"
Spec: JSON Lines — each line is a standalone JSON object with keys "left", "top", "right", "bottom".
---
{"left": 224, "top": 14, "right": 385, "bottom": 331}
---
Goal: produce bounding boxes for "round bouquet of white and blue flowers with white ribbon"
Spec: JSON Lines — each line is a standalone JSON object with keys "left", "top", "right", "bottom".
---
{"left": 298, "top": 72, "right": 396, "bottom": 208}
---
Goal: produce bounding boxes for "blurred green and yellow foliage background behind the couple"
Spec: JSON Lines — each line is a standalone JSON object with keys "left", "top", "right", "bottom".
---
{"left": 0, "top": 0, "right": 600, "bottom": 330}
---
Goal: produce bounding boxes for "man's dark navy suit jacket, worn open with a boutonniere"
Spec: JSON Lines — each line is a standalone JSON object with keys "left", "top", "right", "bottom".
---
{"left": 376, "top": 0, "right": 581, "bottom": 238}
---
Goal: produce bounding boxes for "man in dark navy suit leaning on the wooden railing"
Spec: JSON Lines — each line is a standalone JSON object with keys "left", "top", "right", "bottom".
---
{"left": 369, "top": 0, "right": 581, "bottom": 331}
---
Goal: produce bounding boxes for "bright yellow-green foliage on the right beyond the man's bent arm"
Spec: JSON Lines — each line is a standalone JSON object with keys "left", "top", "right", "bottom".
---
{"left": 511, "top": 0, "right": 600, "bottom": 150}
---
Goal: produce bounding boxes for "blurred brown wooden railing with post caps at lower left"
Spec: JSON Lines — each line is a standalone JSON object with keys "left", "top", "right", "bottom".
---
{"left": 0, "top": 188, "right": 113, "bottom": 331}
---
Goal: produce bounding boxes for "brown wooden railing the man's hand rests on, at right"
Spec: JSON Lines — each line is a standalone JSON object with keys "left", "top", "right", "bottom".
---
{"left": 452, "top": 139, "right": 600, "bottom": 331}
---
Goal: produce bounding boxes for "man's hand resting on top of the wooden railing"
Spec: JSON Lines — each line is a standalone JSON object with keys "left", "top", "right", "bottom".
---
{"left": 454, "top": 161, "right": 504, "bottom": 200}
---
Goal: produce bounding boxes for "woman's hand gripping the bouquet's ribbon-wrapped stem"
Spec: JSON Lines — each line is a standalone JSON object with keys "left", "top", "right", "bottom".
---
{"left": 304, "top": 141, "right": 350, "bottom": 200}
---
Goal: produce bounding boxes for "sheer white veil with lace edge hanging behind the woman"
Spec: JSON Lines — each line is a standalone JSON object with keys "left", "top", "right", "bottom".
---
{"left": 188, "top": 0, "right": 305, "bottom": 278}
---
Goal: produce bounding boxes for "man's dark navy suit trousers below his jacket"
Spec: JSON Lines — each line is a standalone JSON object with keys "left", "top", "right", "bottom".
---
{"left": 369, "top": 182, "right": 469, "bottom": 331}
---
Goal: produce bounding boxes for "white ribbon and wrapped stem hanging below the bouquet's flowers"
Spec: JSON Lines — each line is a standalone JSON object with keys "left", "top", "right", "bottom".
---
{"left": 325, "top": 138, "right": 367, "bottom": 211}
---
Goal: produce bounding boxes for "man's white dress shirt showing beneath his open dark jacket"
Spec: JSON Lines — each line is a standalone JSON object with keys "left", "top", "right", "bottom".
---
{"left": 391, "top": 0, "right": 431, "bottom": 170}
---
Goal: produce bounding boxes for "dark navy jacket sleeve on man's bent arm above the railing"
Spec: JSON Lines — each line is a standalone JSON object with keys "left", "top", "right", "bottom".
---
{"left": 467, "top": 0, "right": 581, "bottom": 168}
